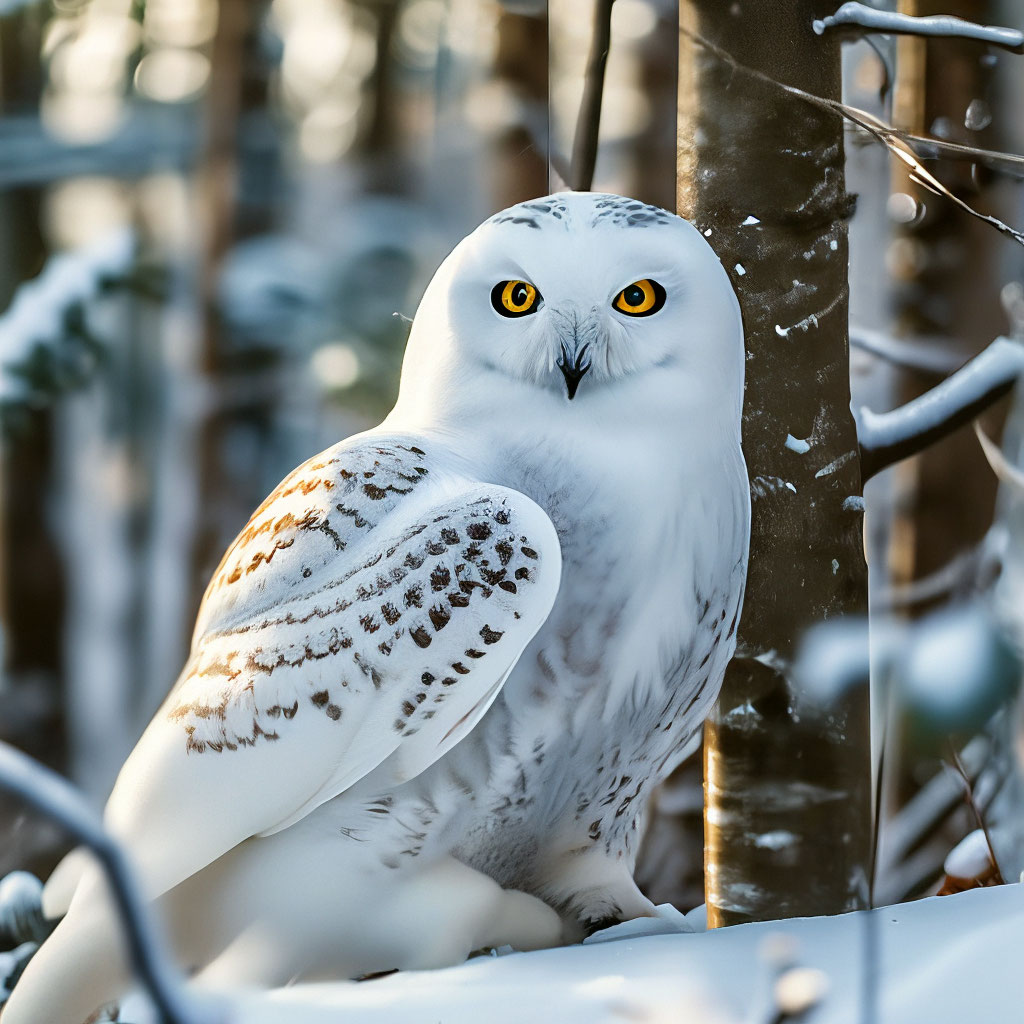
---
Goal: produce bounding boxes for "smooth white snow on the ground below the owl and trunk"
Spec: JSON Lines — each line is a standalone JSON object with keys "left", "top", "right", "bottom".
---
{"left": 186, "top": 886, "right": 1024, "bottom": 1024}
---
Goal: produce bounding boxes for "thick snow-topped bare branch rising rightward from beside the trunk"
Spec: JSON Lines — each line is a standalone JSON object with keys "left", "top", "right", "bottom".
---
{"left": 856, "top": 338, "right": 1024, "bottom": 480}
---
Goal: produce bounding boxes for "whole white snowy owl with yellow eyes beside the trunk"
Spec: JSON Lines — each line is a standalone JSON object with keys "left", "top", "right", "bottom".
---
{"left": 3, "top": 193, "right": 750, "bottom": 1024}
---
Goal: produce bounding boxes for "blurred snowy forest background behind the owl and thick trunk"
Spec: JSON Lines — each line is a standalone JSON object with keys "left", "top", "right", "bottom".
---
{"left": 0, "top": 0, "right": 1024, "bottom": 921}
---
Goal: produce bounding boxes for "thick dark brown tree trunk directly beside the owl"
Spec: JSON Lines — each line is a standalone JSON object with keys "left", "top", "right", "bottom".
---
{"left": 677, "top": 0, "right": 871, "bottom": 926}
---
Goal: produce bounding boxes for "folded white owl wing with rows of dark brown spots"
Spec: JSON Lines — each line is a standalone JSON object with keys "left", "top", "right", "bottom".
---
{"left": 96, "top": 434, "right": 561, "bottom": 898}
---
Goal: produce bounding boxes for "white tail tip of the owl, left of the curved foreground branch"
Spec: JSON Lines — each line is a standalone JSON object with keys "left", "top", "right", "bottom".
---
{"left": 0, "top": 890, "right": 131, "bottom": 1024}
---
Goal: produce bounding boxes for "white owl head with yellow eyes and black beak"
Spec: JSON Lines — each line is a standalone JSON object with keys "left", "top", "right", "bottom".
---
{"left": 391, "top": 193, "right": 744, "bottom": 436}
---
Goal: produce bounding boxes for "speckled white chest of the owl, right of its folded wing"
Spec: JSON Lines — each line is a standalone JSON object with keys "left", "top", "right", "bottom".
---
{"left": 454, "top": 444, "right": 741, "bottom": 862}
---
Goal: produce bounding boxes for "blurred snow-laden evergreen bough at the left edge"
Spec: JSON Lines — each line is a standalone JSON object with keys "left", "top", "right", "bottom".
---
{"left": 0, "top": 229, "right": 135, "bottom": 401}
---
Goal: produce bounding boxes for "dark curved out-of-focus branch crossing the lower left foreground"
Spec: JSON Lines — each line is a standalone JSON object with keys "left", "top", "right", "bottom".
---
{"left": 0, "top": 741, "right": 220, "bottom": 1024}
